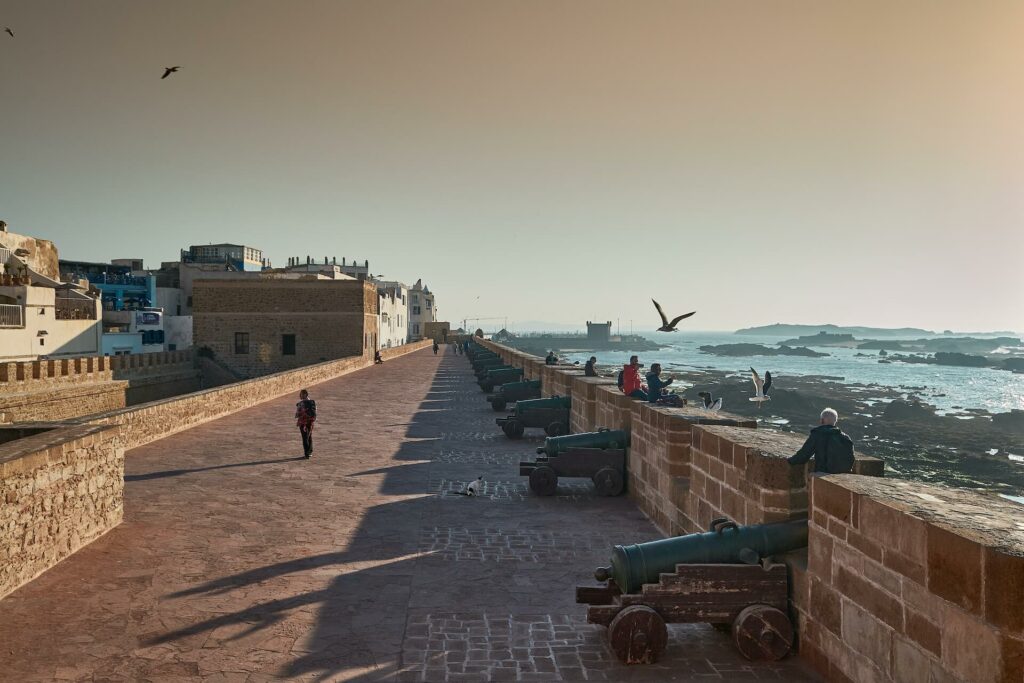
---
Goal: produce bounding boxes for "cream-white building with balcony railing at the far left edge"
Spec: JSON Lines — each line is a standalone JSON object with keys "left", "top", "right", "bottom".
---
{"left": 0, "top": 221, "right": 102, "bottom": 360}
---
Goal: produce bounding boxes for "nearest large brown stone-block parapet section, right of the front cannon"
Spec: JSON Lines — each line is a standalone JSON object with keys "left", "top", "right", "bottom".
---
{"left": 794, "top": 474, "right": 1024, "bottom": 683}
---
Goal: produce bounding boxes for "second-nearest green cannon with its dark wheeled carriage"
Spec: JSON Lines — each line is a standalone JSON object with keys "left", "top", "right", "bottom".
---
{"left": 519, "top": 429, "right": 630, "bottom": 496}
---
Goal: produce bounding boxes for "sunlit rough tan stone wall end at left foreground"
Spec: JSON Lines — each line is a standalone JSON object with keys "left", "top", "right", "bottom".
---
{"left": 0, "top": 425, "right": 124, "bottom": 598}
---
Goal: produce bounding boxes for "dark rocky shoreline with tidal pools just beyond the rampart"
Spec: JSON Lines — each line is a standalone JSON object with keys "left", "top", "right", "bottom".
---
{"left": 607, "top": 367, "right": 1024, "bottom": 497}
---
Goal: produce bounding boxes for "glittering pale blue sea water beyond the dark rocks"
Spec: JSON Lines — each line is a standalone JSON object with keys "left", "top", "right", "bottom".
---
{"left": 561, "top": 331, "right": 1024, "bottom": 414}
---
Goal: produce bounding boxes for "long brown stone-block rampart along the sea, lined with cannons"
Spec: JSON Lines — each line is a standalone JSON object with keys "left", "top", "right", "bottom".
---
{"left": 481, "top": 341, "right": 1024, "bottom": 683}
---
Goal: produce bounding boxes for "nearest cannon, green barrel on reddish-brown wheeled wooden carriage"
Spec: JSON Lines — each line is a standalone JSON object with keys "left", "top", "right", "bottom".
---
{"left": 577, "top": 518, "right": 807, "bottom": 664}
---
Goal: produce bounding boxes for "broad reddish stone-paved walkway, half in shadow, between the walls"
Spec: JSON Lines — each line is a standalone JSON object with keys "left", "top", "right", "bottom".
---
{"left": 0, "top": 351, "right": 815, "bottom": 682}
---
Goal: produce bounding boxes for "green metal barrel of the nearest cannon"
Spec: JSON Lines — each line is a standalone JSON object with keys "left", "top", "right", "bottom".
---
{"left": 594, "top": 519, "right": 807, "bottom": 593}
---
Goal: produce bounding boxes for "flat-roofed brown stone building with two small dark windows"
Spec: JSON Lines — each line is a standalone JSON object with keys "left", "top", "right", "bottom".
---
{"left": 193, "top": 276, "right": 379, "bottom": 378}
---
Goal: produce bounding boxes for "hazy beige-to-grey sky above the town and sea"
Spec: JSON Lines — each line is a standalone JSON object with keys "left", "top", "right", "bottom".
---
{"left": 0, "top": 0, "right": 1024, "bottom": 330}
